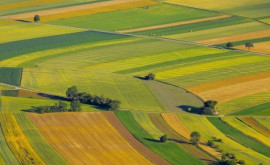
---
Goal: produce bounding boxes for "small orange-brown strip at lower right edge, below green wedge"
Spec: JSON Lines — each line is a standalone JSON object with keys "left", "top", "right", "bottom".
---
{"left": 239, "top": 117, "right": 270, "bottom": 138}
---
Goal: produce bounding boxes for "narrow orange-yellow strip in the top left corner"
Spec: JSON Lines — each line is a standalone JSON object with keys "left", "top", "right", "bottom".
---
{"left": 0, "top": 0, "right": 64, "bottom": 10}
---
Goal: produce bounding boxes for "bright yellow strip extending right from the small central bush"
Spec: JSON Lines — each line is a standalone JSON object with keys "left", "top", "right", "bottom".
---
{"left": 156, "top": 56, "right": 268, "bottom": 79}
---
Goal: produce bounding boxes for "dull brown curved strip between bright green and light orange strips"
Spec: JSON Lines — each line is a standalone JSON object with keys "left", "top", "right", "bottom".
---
{"left": 148, "top": 113, "right": 216, "bottom": 164}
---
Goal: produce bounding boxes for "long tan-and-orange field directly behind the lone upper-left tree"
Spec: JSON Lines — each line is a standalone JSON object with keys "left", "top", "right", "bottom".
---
{"left": 8, "top": 0, "right": 158, "bottom": 22}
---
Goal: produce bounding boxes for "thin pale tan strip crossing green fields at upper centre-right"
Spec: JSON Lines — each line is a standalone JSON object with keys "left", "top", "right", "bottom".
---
{"left": 118, "top": 14, "right": 231, "bottom": 33}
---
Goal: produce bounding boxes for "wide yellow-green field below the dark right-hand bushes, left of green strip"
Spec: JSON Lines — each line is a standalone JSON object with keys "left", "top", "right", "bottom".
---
{"left": 178, "top": 114, "right": 270, "bottom": 165}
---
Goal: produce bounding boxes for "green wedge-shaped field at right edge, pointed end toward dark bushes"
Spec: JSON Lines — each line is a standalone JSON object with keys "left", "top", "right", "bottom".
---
{"left": 231, "top": 102, "right": 270, "bottom": 116}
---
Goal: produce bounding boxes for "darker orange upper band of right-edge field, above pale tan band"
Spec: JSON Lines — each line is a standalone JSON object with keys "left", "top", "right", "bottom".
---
{"left": 187, "top": 71, "right": 270, "bottom": 93}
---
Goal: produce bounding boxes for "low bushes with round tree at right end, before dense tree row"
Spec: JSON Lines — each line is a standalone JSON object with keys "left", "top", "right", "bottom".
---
{"left": 34, "top": 100, "right": 81, "bottom": 113}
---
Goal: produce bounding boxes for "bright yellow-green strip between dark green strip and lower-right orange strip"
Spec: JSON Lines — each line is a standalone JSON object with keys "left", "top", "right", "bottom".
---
{"left": 222, "top": 117, "right": 270, "bottom": 148}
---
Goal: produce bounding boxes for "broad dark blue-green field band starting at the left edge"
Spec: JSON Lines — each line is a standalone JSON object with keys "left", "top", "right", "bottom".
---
{"left": 0, "top": 31, "right": 127, "bottom": 60}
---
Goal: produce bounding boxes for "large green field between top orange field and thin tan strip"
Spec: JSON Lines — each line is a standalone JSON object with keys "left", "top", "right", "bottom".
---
{"left": 50, "top": 4, "right": 217, "bottom": 31}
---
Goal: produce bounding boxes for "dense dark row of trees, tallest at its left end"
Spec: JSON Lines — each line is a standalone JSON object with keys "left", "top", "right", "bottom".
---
{"left": 66, "top": 86, "right": 121, "bottom": 111}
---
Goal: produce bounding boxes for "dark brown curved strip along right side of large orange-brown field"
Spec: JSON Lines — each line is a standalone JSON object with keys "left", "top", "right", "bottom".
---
{"left": 103, "top": 112, "right": 169, "bottom": 165}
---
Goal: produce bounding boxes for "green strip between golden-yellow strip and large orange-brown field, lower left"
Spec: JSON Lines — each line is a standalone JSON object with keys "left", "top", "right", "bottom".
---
{"left": 14, "top": 113, "right": 68, "bottom": 165}
